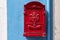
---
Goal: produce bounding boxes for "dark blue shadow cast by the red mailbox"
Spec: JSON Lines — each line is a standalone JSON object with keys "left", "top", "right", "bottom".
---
{"left": 26, "top": 11, "right": 48, "bottom": 40}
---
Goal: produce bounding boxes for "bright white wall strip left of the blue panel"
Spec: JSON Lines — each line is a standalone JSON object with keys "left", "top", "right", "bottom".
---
{"left": 0, "top": 0, "right": 7, "bottom": 40}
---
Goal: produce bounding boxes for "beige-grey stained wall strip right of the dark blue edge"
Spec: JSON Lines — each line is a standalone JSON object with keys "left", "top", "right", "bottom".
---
{"left": 54, "top": 0, "right": 60, "bottom": 40}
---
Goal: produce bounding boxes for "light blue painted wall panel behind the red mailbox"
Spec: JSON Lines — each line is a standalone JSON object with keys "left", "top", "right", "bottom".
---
{"left": 7, "top": 0, "right": 51, "bottom": 40}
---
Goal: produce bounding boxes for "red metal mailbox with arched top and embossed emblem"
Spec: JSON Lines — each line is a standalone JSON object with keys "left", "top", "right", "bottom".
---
{"left": 24, "top": 1, "right": 46, "bottom": 37}
